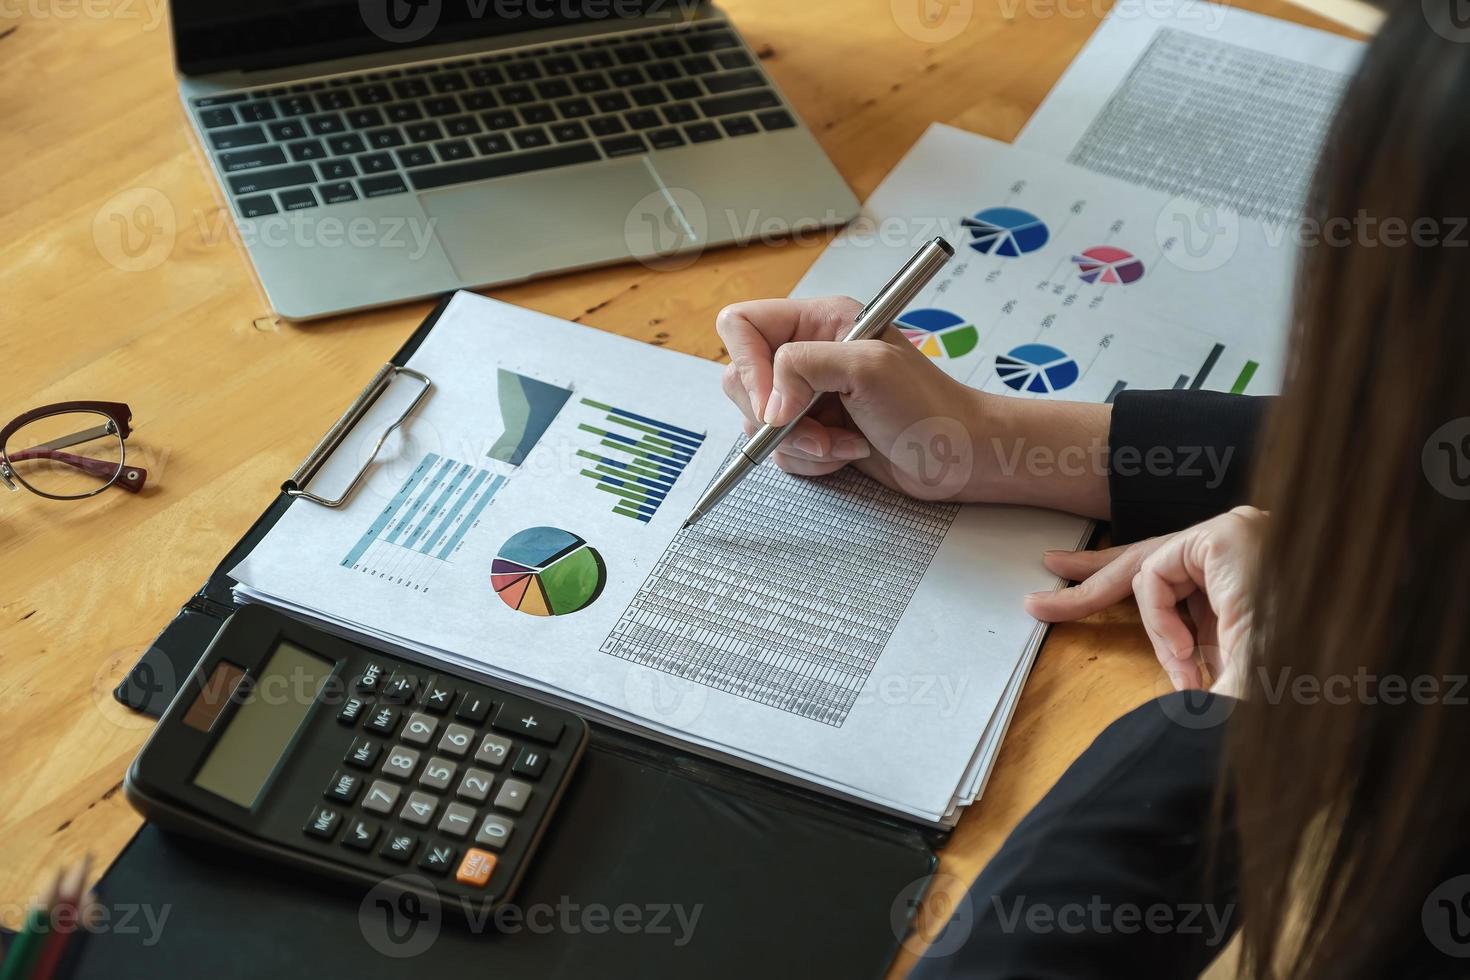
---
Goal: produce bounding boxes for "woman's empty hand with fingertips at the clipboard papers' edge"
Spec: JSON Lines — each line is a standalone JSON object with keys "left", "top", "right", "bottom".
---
{"left": 1026, "top": 507, "right": 1267, "bottom": 696}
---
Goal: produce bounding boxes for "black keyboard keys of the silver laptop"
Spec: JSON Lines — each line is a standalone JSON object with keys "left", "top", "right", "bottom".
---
{"left": 193, "top": 21, "right": 797, "bottom": 217}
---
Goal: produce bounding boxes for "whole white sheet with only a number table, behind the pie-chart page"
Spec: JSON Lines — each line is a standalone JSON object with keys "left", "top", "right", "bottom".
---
{"left": 1016, "top": 0, "right": 1363, "bottom": 223}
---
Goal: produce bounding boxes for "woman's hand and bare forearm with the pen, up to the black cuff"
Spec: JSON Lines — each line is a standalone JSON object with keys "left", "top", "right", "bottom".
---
{"left": 714, "top": 297, "right": 1110, "bottom": 517}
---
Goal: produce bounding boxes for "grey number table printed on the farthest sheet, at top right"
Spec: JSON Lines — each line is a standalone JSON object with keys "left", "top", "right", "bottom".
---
{"left": 1067, "top": 28, "right": 1347, "bottom": 223}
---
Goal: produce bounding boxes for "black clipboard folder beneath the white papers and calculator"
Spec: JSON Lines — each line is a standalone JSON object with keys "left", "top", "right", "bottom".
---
{"left": 106, "top": 297, "right": 947, "bottom": 980}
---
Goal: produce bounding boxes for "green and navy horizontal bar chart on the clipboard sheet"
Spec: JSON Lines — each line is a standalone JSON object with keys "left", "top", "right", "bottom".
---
{"left": 576, "top": 398, "right": 704, "bottom": 525}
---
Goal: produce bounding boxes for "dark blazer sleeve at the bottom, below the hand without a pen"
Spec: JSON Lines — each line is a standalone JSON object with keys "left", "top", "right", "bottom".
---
{"left": 910, "top": 691, "right": 1239, "bottom": 980}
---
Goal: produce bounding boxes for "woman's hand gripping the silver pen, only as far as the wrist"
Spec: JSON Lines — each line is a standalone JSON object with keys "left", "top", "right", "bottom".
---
{"left": 714, "top": 297, "right": 988, "bottom": 500}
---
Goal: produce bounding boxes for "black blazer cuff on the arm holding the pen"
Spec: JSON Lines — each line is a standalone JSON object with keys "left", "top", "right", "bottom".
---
{"left": 1108, "top": 391, "right": 1272, "bottom": 544}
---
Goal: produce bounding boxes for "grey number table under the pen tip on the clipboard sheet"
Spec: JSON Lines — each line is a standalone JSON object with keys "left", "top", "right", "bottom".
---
{"left": 603, "top": 450, "right": 958, "bottom": 727}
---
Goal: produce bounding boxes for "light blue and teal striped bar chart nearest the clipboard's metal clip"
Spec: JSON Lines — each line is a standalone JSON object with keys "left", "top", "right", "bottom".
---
{"left": 341, "top": 453, "right": 506, "bottom": 592}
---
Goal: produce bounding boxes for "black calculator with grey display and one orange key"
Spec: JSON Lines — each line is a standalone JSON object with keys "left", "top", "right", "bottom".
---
{"left": 123, "top": 605, "right": 588, "bottom": 914}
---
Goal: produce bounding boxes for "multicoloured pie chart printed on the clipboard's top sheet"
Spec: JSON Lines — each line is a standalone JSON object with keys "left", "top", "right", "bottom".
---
{"left": 490, "top": 527, "right": 607, "bottom": 616}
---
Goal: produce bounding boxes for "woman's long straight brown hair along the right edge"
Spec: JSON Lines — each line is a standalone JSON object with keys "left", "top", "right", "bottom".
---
{"left": 1223, "top": 0, "right": 1470, "bottom": 979}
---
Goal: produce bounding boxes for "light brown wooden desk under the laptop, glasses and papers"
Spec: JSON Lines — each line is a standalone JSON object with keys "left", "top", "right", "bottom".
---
{"left": 0, "top": 0, "right": 1346, "bottom": 973}
